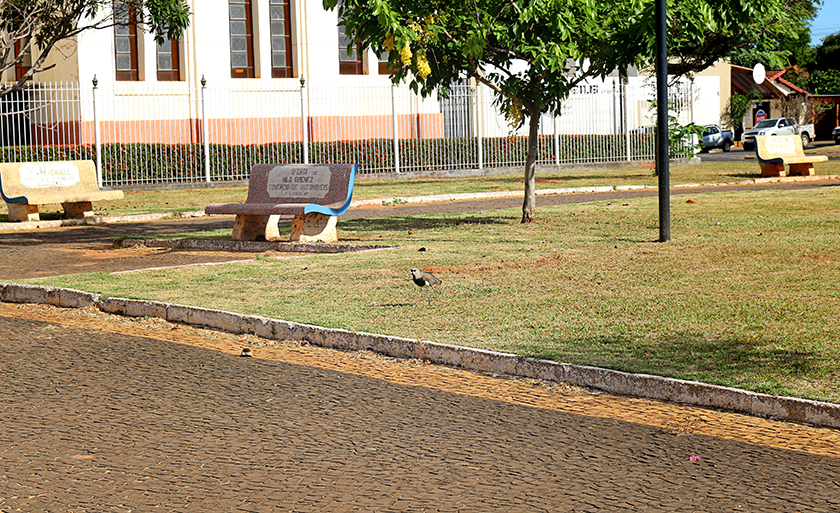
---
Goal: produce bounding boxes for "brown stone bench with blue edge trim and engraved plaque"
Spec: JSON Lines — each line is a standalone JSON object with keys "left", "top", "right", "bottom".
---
{"left": 204, "top": 164, "right": 359, "bottom": 243}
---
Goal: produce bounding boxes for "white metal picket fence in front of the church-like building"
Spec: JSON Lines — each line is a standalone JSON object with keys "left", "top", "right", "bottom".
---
{"left": 0, "top": 79, "right": 692, "bottom": 186}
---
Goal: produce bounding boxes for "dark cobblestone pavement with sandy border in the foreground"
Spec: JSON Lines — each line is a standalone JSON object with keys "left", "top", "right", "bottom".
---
{"left": 0, "top": 304, "right": 840, "bottom": 513}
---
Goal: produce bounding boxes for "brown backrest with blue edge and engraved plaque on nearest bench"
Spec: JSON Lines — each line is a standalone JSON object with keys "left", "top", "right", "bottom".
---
{"left": 246, "top": 164, "right": 359, "bottom": 212}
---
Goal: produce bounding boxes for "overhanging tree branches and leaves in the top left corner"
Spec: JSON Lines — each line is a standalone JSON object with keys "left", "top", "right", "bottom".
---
{"left": 0, "top": 0, "right": 189, "bottom": 96}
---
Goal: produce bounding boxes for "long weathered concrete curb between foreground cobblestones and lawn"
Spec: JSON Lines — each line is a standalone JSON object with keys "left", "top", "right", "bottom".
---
{"left": 0, "top": 282, "right": 840, "bottom": 428}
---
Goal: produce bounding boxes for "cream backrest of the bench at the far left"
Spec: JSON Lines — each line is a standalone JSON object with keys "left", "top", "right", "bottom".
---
{"left": 0, "top": 160, "right": 110, "bottom": 204}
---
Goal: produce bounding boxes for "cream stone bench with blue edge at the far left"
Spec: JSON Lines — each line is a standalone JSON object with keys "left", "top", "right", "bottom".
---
{"left": 0, "top": 160, "right": 123, "bottom": 221}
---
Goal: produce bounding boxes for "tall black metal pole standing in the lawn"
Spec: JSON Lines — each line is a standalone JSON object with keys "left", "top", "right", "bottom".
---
{"left": 656, "top": 0, "right": 671, "bottom": 242}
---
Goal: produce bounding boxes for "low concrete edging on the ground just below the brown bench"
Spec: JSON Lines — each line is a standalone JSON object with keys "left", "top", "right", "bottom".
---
{"left": 114, "top": 239, "right": 396, "bottom": 253}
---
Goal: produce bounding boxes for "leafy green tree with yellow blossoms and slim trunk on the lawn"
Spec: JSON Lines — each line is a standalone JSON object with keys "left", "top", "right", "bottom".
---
{"left": 323, "top": 0, "right": 811, "bottom": 222}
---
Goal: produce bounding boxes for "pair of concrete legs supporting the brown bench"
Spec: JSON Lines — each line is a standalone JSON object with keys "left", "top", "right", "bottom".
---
{"left": 230, "top": 213, "right": 338, "bottom": 243}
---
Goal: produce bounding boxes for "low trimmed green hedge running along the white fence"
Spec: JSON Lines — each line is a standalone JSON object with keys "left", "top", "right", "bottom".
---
{"left": 0, "top": 134, "right": 653, "bottom": 185}
